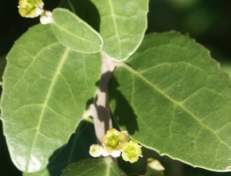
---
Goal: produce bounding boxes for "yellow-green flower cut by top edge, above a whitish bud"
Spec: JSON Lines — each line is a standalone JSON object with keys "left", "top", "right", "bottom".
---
{"left": 18, "top": 0, "right": 44, "bottom": 18}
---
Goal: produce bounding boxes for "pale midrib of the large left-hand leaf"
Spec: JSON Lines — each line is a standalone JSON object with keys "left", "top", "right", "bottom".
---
{"left": 26, "top": 48, "right": 70, "bottom": 171}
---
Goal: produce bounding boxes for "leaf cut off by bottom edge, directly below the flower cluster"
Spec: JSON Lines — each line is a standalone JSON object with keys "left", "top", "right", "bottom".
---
{"left": 62, "top": 158, "right": 125, "bottom": 176}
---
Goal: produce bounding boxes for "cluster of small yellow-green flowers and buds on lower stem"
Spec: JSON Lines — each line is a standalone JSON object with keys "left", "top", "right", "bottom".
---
{"left": 89, "top": 128, "right": 142, "bottom": 163}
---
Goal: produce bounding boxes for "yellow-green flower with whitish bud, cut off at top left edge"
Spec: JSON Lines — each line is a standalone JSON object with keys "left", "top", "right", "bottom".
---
{"left": 18, "top": 0, "right": 52, "bottom": 24}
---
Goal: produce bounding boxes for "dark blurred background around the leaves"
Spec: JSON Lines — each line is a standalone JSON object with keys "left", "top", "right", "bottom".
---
{"left": 0, "top": 0, "right": 231, "bottom": 176}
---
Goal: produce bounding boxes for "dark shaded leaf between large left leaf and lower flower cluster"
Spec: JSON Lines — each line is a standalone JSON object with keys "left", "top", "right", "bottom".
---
{"left": 24, "top": 121, "right": 97, "bottom": 176}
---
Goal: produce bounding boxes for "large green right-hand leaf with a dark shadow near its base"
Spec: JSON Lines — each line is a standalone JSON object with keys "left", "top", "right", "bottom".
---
{"left": 111, "top": 32, "right": 231, "bottom": 171}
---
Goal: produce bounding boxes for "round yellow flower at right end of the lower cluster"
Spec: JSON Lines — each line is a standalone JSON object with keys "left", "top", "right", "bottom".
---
{"left": 122, "top": 141, "right": 142, "bottom": 163}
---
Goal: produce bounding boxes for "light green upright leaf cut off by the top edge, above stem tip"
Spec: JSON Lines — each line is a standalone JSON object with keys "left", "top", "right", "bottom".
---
{"left": 92, "top": 0, "right": 149, "bottom": 60}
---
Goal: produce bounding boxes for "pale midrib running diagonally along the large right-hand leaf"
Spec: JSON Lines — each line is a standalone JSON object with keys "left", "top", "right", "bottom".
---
{"left": 119, "top": 63, "right": 231, "bottom": 149}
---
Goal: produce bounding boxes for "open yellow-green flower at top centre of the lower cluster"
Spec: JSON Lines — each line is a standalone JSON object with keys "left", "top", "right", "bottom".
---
{"left": 103, "top": 128, "right": 129, "bottom": 152}
